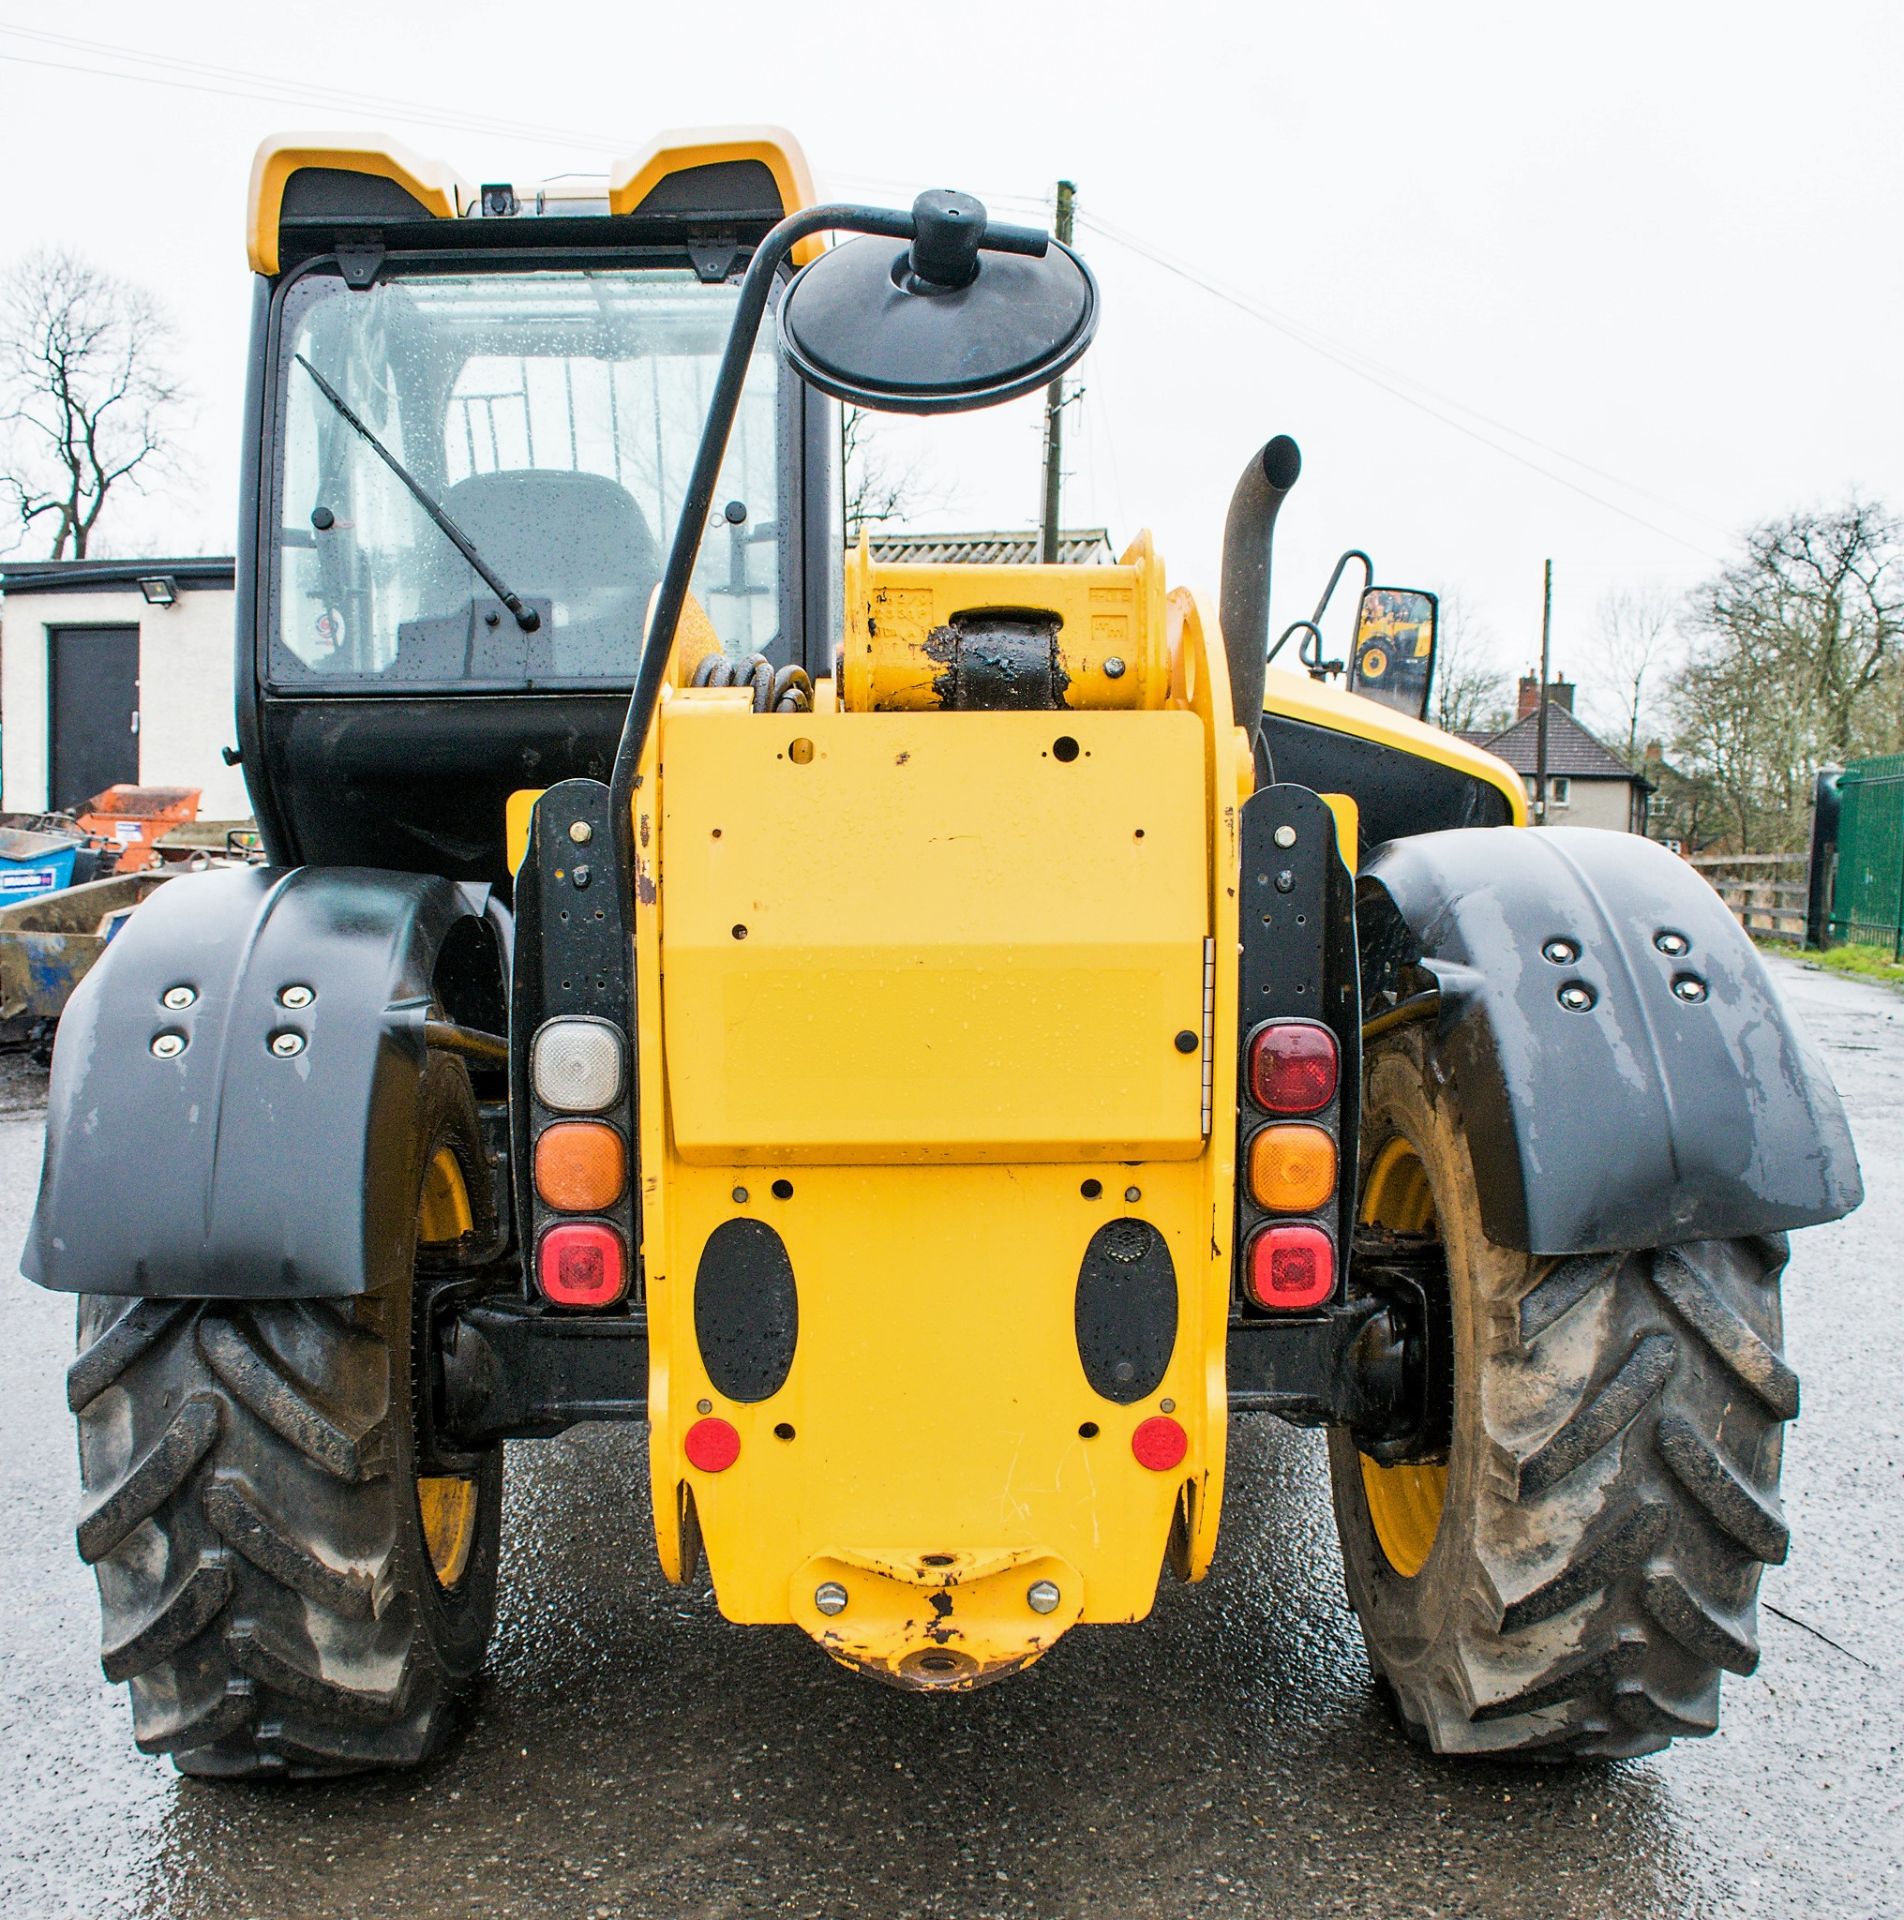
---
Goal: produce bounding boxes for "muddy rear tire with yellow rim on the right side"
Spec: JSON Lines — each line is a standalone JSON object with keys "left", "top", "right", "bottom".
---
{"left": 1330, "top": 1027, "right": 1798, "bottom": 1759}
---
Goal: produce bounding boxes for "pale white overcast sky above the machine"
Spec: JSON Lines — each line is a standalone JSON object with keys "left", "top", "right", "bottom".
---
{"left": 0, "top": 0, "right": 1904, "bottom": 733}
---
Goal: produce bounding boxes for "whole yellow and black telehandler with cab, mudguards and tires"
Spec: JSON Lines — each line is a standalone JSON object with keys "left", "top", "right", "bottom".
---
{"left": 27, "top": 132, "right": 1860, "bottom": 1776}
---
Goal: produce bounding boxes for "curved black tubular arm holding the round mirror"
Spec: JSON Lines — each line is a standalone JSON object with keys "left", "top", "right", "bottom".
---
{"left": 608, "top": 194, "right": 1050, "bottom": 879}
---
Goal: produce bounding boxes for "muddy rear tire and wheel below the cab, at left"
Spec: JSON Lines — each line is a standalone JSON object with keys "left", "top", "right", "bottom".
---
{"left": 67, "top": 1056, "right": 503, "bottom": 1778}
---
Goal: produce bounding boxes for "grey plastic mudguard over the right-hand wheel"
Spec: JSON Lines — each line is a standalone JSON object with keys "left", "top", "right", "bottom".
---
{"left": 1357, "top": 828, "right": 1864, "bottom": 1254}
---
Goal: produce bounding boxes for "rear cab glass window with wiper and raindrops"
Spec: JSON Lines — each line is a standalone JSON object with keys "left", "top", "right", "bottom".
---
{"left": 271, "top": 267, "right": 787, "bottom": 689}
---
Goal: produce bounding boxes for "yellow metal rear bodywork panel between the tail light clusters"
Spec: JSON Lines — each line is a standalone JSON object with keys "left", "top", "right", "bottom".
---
{"left": 621, "top": 545, "right": 1248, "bottom": 1688}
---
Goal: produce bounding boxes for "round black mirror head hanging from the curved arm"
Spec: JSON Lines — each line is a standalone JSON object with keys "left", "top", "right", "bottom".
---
{"left": 779, "top": 192, "right": 1098, "bottom": 413}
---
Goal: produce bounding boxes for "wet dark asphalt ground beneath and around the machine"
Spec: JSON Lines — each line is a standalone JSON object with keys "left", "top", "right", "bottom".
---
{"left": 0, "top": 962, "right": 1904, "bottom": 1920}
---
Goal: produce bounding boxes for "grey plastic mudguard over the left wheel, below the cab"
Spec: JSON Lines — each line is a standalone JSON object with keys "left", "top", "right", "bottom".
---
{"left": 21, "top": 868, "right": 488, "bottom": 1300}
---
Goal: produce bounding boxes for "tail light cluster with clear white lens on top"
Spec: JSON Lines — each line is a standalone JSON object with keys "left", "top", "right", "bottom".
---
{"left": 530, "top": 1018, "right": 628, "bottom": 1308}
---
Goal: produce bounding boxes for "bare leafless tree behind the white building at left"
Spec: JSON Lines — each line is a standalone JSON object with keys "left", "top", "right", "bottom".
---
{"left": 0, "top": 252, "right": 184, "bottom": 561}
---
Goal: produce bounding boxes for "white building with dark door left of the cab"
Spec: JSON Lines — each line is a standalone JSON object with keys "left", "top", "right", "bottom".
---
{"left": 0, "top": 559, "right": 251, "bottom": 820}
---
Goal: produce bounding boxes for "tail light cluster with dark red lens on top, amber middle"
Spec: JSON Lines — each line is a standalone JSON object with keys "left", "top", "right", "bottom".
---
{"left": 1238, "top": 1020, "right": 1342, "bottom": 1313}
